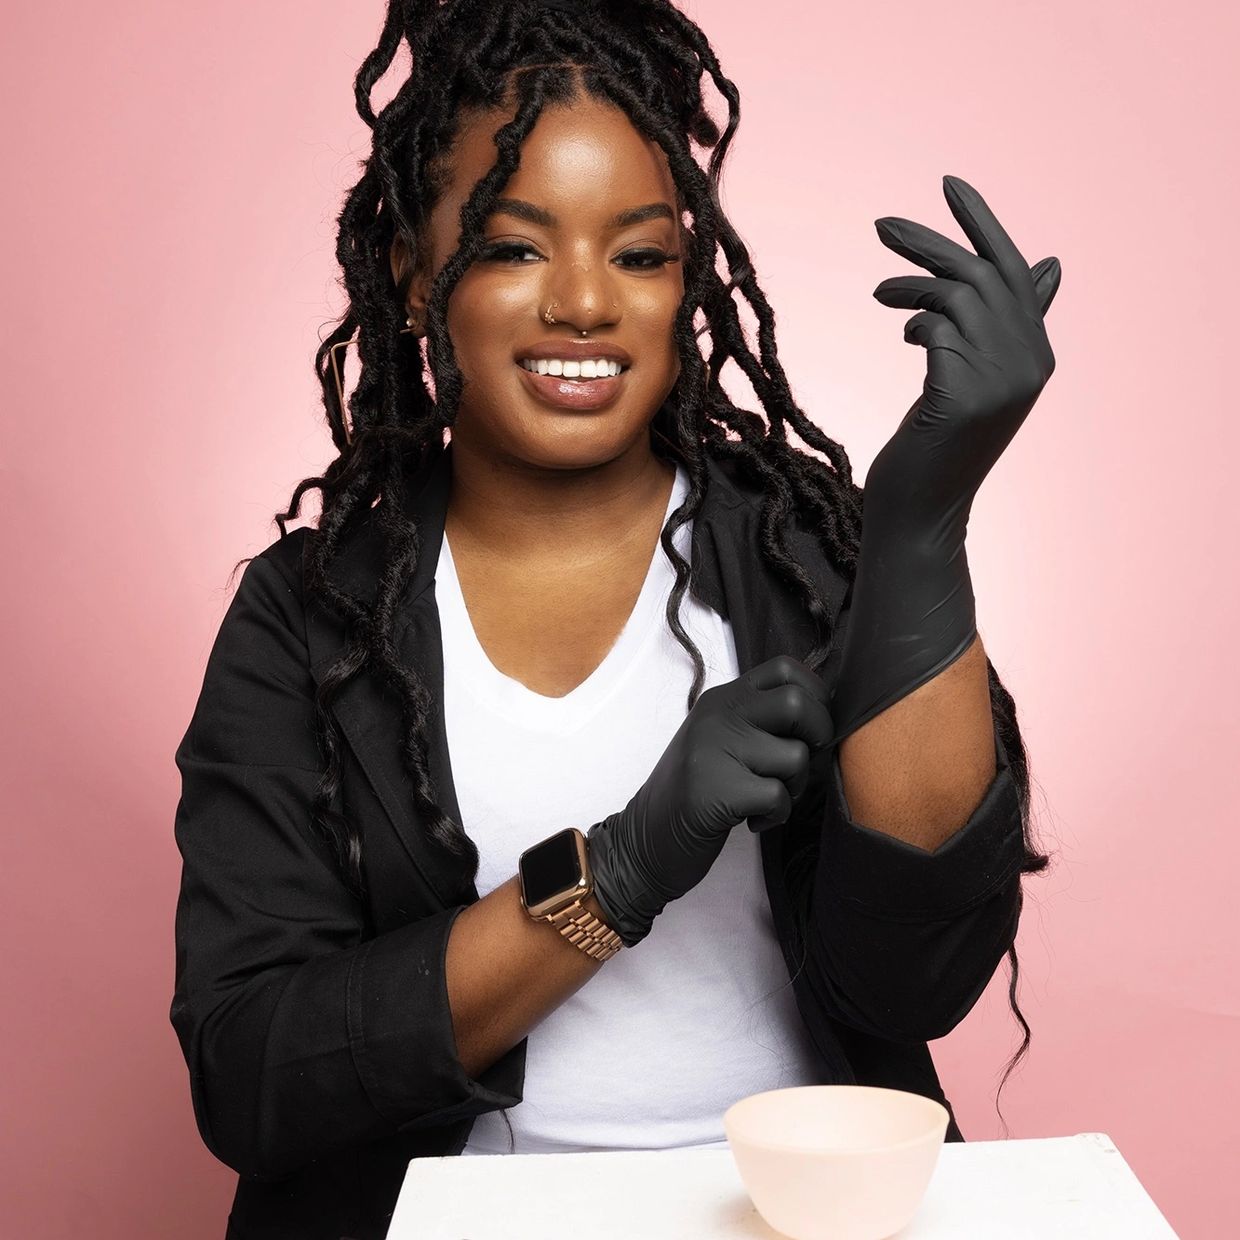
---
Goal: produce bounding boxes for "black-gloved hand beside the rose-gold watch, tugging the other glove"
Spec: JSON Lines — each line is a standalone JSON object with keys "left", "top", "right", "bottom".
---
{"left": 587, "top": 655, "right": 832, "bottom": 947}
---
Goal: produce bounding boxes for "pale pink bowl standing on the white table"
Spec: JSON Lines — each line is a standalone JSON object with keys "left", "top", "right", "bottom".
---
{"left": 723, "top": 1085, "right": 949, "bottom": 1240}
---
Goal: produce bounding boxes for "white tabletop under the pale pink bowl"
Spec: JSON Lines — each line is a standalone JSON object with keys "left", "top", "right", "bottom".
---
{"left": 388, "top": 1132, "right": 1176, "bottom": 1240}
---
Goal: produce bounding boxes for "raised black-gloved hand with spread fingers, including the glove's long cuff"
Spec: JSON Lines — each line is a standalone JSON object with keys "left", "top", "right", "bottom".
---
{"left": 831, "top": 176, "right": 1060, "bottom": 744}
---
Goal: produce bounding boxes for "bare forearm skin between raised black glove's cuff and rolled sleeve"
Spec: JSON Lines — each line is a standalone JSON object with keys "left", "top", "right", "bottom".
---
{"left": 839, "top": 636, "right": 997, "bottom": 852}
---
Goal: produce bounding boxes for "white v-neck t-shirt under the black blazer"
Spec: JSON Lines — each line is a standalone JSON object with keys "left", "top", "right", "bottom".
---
{"left": 435, "top": 465, "right": 822, "bottom": 1154}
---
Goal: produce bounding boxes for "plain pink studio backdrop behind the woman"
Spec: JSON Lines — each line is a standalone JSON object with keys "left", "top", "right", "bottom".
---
{"left": 0, "top": 0, "right": 1240, "bottom": 1240}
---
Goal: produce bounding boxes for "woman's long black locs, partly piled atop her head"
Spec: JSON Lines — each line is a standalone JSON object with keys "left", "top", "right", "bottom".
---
{"left": 239, "top": 0, "right": 1049, "bottom": 1135}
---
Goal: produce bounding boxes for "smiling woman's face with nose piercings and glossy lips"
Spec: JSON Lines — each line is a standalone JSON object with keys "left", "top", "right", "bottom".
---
{"left": 393, "top": 95, "right": 684, "bottom": 469}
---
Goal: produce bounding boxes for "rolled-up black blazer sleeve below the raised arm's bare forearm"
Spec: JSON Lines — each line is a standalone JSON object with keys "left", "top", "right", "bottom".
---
{"left": 806, "top": 585, "right": 1024, "bottom": 1042}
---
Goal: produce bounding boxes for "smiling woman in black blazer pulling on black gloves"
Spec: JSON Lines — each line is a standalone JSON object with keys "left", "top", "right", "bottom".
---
{"left": 171, "top": 0, "right": 1058, "bottom": 1238}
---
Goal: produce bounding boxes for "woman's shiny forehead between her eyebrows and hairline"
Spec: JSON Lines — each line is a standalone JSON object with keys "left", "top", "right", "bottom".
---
{"left": 445, "top": 98, "right": 676, "bottom": 224}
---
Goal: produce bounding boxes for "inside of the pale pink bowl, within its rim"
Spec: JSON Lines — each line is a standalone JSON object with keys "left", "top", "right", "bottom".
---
{"left": 724, "top": 1085, "right": 947, "bottom": 1152}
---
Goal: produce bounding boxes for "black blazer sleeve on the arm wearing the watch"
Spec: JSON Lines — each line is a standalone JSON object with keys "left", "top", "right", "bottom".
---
{"left": 170, "top": 544, "right": 523, "bottom": 1179}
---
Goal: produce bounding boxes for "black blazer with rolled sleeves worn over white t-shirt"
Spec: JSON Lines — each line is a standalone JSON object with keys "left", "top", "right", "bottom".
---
{"left": 170, "top": 446, "right": 1023, "bottom": 1240}
